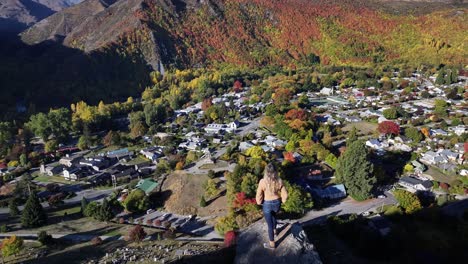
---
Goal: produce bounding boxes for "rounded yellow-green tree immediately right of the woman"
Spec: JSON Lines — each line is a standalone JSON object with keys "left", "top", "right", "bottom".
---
{"left": 281, "top": 181, "right": 314, "bottom": 214}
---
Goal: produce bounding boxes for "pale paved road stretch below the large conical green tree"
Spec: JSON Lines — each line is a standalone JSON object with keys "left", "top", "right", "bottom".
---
{"left": 299, "top": 192, "right": 397, "bottom": 225}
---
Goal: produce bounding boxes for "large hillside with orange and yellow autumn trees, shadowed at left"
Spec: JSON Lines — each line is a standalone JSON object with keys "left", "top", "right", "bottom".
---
{"left": 0, "top": 0, "right": 468, "bottom": 116}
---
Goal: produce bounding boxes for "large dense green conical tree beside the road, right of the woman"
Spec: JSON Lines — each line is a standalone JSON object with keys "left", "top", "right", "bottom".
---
{"left": 335, "top": 140, "right": 377, "bottom": 201}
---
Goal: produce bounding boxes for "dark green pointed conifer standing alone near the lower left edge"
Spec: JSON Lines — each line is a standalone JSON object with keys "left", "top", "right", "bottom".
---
{"left": 21, "top": 192, "right": 47, "bottom": 228}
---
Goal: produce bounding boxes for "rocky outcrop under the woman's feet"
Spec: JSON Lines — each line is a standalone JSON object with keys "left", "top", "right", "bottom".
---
{"left": 234, "top": 220, "right": 322, "bottom": 264}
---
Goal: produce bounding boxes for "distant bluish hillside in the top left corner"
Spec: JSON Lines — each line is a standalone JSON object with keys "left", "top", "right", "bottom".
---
{"left": 0, "top": 0, "right": 81, "bottom": 33}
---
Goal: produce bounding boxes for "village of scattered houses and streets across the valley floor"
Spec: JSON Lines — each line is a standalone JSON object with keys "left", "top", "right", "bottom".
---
{"left": 0, "top": 67, "right": 468, "bottom": 262}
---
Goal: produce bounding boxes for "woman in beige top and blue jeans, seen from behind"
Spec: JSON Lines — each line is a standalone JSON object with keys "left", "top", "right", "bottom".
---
{"left": 256, "top": 163, "right": 288, "bottom": 249}
